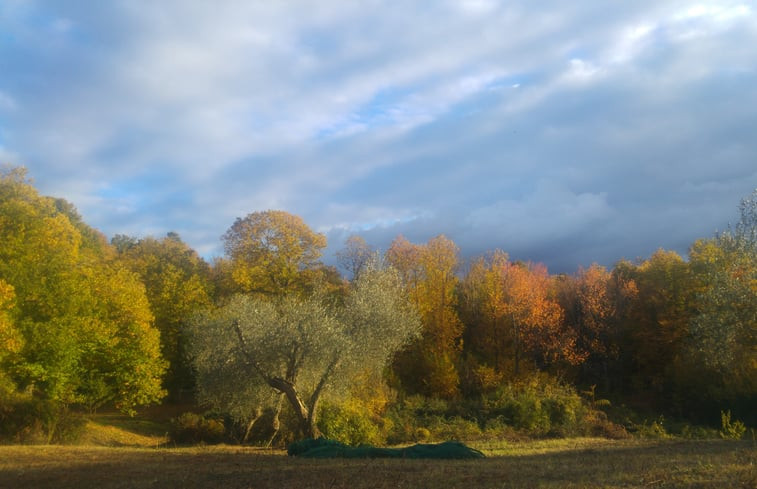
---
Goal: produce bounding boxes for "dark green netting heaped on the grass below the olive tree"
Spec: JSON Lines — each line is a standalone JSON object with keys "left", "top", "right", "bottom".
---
{"left": 287, "top": 438, "right": 484, "bottom": 459}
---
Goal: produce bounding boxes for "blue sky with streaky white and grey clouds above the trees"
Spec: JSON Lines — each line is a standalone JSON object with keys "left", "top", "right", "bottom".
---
{"left": 0, "top": 0, "right": 757, "bottom": 272}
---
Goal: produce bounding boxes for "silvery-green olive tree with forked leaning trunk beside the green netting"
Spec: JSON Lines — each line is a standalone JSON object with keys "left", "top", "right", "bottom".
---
{"left": 189, "top": 264, "right": 420, "bottom": 437}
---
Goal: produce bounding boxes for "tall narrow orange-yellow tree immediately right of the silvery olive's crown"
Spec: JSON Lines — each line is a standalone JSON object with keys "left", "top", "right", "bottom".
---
{"left": 386, "top": 236, "right": 463, "bottom": 398}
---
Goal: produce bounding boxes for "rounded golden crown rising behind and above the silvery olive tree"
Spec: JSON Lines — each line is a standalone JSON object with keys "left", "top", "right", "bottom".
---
{"left": 223, "top": 210, "right": 326, "bottom": 296}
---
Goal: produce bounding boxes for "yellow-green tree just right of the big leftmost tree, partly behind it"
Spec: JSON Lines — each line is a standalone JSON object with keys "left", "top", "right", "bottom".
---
{"left": 116, "top": 233, "right": 212, "bottom": 400}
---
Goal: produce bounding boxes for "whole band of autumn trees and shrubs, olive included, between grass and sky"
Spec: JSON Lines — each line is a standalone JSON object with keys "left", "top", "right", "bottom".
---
{"left": 0, "top": 167, "right": 757, "bottom": 445}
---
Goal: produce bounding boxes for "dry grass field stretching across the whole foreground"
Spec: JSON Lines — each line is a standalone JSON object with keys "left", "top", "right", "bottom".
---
{"left": 0, "top": 439, "right": 757, "bottom": 489}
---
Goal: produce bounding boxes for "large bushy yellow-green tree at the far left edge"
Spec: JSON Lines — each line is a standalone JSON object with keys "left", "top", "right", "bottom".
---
{"left": 0, "top": 169, "right": 164, "bottom": 411}
